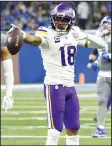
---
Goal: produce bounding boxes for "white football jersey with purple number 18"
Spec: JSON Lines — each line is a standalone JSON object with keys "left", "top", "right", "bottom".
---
{"left": 35, "top": 26, "right": 80, "bottom": 87}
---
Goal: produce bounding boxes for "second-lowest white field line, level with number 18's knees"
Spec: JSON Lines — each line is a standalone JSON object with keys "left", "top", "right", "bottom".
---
{"left": 1, "top": 125, "right": 111, "bottom": 130}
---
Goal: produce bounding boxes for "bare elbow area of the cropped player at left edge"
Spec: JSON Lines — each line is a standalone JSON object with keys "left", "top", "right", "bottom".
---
{"left": 1, "top": 46, "right": 11, "bottom": 60}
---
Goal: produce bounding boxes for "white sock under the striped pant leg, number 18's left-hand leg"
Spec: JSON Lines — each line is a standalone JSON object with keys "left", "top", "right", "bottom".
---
{"left": 46, "top": 129, "right": 60, "bottom": 145}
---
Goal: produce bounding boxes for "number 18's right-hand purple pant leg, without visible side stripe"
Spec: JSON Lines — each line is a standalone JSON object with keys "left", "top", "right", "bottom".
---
{"left": 64, "top": 88, "right": 80, "bottom": 131}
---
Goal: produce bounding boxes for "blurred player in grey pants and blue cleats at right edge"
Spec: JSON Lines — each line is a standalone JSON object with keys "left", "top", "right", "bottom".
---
{"left": 88, "top": 16, "right": 112, "bottom": 137}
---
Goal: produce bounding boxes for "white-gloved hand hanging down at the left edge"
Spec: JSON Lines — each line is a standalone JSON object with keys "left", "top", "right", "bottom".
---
{"left": 3, "top": 96, "right": 14, "bottom": 111}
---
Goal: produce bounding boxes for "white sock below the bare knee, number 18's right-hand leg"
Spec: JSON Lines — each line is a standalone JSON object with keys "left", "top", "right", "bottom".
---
{"left": 66, "top": 135, "right": 79, "bottom": 146}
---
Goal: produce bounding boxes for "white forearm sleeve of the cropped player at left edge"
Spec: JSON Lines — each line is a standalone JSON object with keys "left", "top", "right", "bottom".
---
{"left": 2, "top": 59, "right": 14, "bottom": 96}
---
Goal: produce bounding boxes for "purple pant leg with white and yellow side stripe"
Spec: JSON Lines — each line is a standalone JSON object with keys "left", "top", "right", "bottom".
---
{"left": 44, "top": 85, "right": 65, "bottom": 131}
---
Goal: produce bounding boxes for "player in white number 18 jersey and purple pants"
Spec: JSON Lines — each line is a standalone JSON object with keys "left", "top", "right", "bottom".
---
{"left": 9, "top": 4, "right": 106, "bottom": 145}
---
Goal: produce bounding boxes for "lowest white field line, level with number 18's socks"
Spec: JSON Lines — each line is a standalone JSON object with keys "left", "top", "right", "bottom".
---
{"left": 1, "top": 135, "right": 111, "bottom": 139}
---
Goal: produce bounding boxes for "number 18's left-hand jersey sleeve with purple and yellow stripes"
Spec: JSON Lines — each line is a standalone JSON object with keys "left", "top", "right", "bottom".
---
{"left": 35, "top": 27, "right": 49, "bottom": 49}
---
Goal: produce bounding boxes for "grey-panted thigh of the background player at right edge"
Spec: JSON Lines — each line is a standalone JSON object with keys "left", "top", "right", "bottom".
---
{"left": 97, "top": 76, "right": 111, "bottom": 102}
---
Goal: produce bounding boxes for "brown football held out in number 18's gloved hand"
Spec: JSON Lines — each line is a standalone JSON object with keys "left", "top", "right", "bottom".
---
{"left": 6, "top": 28, "right": 23, "bottom": 55}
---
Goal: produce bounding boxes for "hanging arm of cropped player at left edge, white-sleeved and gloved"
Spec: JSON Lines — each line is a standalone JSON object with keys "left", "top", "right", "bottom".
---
{"left": 1, "top": 33, "right": 14, "bottom": 110}
